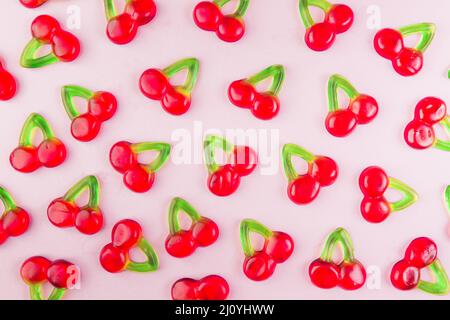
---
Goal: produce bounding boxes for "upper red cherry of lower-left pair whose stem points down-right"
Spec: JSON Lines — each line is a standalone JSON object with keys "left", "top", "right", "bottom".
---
{"left": 112, "top": 219, "right": 142, "bottom": 250}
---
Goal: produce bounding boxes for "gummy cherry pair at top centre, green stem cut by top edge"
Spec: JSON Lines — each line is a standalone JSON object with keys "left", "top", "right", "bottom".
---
{"left": 193, "top": 0, "right": 250, "bottom": 42}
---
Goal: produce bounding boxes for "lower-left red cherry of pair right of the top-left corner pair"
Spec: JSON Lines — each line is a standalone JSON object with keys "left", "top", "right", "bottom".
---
{"left": 106, "top": 13, "right": 138, "bottom": 44}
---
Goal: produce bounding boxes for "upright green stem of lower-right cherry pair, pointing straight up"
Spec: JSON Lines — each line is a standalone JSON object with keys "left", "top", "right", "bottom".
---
{"left": 320, "top": 228, "right": 355, "bottom": 262}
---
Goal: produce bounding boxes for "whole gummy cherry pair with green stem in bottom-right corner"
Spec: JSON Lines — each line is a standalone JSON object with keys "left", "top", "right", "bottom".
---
{"left": 391, "top": 237, "right": 450, "bottom": 295}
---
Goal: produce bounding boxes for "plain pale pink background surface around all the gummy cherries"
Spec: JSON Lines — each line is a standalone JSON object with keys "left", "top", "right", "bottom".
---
{"left": 0, "top": 0, "right": 450, "bottom": 299}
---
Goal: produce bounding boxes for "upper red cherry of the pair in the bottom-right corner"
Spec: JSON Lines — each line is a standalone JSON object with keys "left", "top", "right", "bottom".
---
{"left": 405, "top": 237, "right": 437, "bottom": 269}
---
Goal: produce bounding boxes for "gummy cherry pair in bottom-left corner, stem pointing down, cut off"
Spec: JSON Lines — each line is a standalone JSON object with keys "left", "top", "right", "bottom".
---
{"left": 20, "top": 256, "right": 80, "bottom": 300}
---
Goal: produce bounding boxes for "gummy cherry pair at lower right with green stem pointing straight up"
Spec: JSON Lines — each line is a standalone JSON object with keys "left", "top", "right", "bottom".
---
{"left": 309, "top": 228, "right": 366, "bottom": 290}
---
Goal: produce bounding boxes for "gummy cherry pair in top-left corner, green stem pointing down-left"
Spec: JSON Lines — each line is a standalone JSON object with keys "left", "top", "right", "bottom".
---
{"left": 20, "top": 15, "right": 80, "bottom": 68}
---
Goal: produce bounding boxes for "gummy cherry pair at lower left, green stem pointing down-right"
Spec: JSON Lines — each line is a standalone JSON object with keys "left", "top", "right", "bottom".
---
{"left": 100, "top": 219, "right": 158, "bottom": 273}
